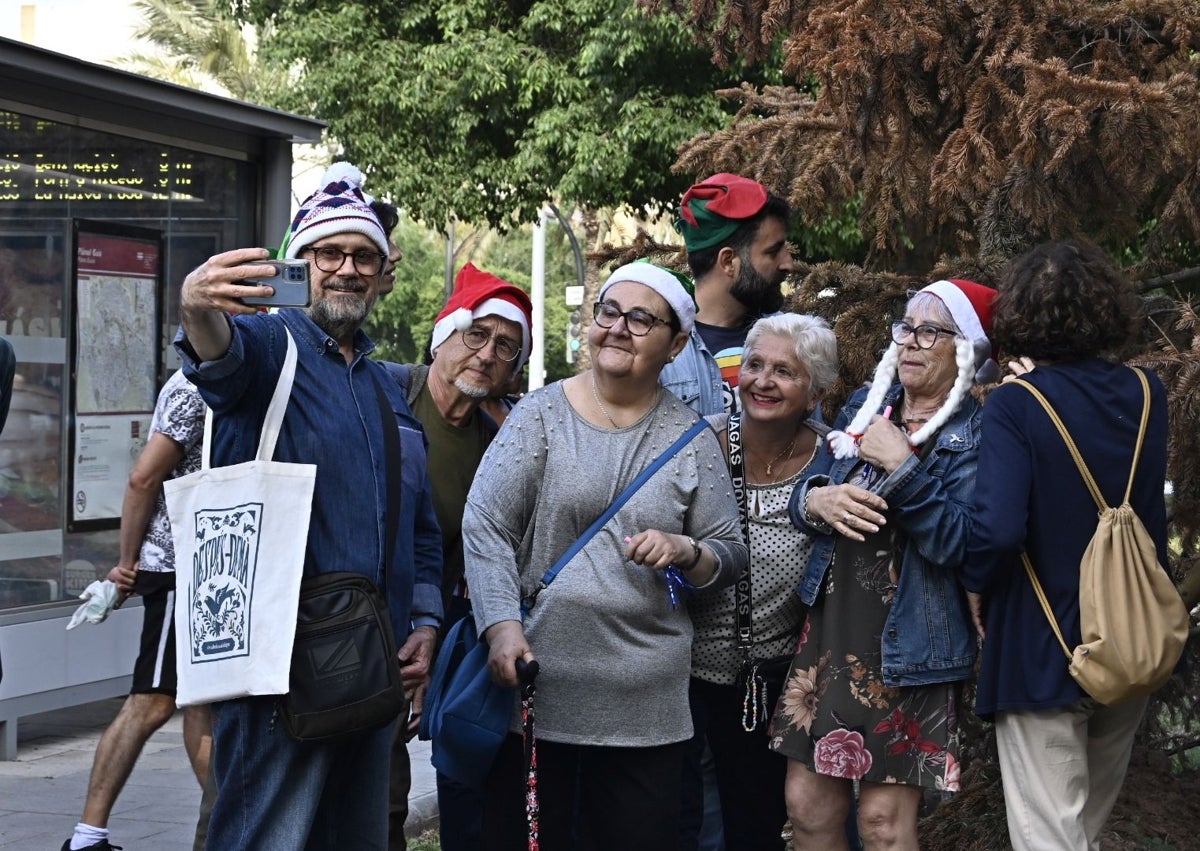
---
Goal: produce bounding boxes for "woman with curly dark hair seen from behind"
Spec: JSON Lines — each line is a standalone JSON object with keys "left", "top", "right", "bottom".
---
{"left": 962, "top": 241, "right": 1168, "bottom": 851}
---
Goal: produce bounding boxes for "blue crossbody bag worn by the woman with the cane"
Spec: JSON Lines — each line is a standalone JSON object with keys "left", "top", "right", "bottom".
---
{"left": 416, "top": 420, "right": 708, "bottom": 789}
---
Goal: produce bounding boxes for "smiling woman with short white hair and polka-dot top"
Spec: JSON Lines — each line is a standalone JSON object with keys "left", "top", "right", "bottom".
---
{"left": 685, "top": 313, "right": 838, "bottom": 851}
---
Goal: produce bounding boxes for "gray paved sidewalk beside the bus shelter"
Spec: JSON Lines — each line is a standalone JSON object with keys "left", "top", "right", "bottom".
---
{"left": 0, "top": 699, "right": 438, "bottom": 851}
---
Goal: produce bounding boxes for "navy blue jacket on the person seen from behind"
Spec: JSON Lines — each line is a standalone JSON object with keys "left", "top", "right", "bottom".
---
{"left": 962, "top": 360, "right": 1166, "bottom": 718}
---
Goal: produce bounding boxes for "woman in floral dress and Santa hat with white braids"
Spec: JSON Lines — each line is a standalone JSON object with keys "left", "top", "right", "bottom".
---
{"left": 770, "top": 280, "right": 998, "bottom": 851}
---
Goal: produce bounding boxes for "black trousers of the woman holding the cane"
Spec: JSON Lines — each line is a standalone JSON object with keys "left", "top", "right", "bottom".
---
{"left": 482, "top": 735, "right": 688, "bottom": 851}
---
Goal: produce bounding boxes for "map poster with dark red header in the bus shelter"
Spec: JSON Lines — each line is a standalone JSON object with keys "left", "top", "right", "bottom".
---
{"left": 68, "top": 222, "right": 162, "bottom": 532}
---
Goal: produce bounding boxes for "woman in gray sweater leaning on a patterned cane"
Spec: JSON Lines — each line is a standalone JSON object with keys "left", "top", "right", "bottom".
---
{"left": 463, "top": 263, "right": 746, "bottom": 851}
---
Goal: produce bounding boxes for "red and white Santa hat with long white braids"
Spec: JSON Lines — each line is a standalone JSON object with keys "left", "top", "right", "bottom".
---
{"left": 826, "top": 278, "right": 1000, "bottom": 459}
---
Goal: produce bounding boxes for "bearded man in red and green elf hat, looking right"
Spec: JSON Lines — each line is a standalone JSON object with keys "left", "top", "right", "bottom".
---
{"left": 659, "top": 173, "right": 793, "bottom": 414}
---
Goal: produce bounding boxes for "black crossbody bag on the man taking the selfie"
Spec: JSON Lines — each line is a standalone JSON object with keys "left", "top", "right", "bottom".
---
{"left": 278, "top": 376, "right": 407, "bottom": 741}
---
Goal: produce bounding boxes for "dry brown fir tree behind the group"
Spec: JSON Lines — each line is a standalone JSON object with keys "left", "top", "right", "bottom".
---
{"left": 593, "top": 0, "right": 1200, "bottom": 850}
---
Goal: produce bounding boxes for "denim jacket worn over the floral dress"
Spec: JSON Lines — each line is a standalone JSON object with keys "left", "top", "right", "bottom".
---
{"left": 788, "top": 383, "right": 983, "bottom": 687}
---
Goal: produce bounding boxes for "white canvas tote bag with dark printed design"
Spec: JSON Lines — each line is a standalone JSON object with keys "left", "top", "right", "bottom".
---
{"left": 163, "top": 332, "right": 317, "bottom": 706}
